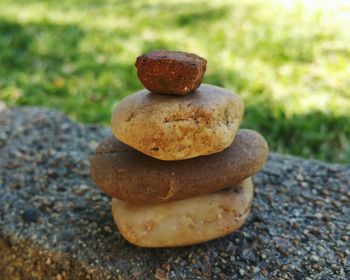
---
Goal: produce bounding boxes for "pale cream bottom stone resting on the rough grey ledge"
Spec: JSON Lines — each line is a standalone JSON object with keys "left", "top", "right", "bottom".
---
{"left": 112, "top": 178, "right": 254, "bottom": 247}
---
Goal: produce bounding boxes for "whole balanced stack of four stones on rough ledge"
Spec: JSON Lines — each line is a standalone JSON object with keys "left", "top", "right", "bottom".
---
{"left": 91, "top": 51, "right": 268, "bottom": 247}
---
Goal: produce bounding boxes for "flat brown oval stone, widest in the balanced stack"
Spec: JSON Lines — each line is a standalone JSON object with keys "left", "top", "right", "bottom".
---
{"left": 91, "top": 130, "right": 268, "bottom": 203}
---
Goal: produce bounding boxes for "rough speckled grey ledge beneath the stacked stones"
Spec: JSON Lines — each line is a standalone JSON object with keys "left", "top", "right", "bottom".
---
{"left": 0, "top": 108, "right": 350, "bottom": 280}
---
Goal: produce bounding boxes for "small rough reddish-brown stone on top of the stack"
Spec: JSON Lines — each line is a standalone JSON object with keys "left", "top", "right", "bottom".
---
{"left": 135, "top": 50, "right": 207, "bottom": 95}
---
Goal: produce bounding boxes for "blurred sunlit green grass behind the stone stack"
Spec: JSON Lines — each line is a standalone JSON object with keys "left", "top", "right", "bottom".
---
{"left": 0, "top": 0, "right": 350, "bottom": 163}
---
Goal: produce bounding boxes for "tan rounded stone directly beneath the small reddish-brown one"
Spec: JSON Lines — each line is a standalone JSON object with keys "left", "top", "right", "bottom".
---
{"left": 112, "top": 84, "right": 244, "bottom": 160}
